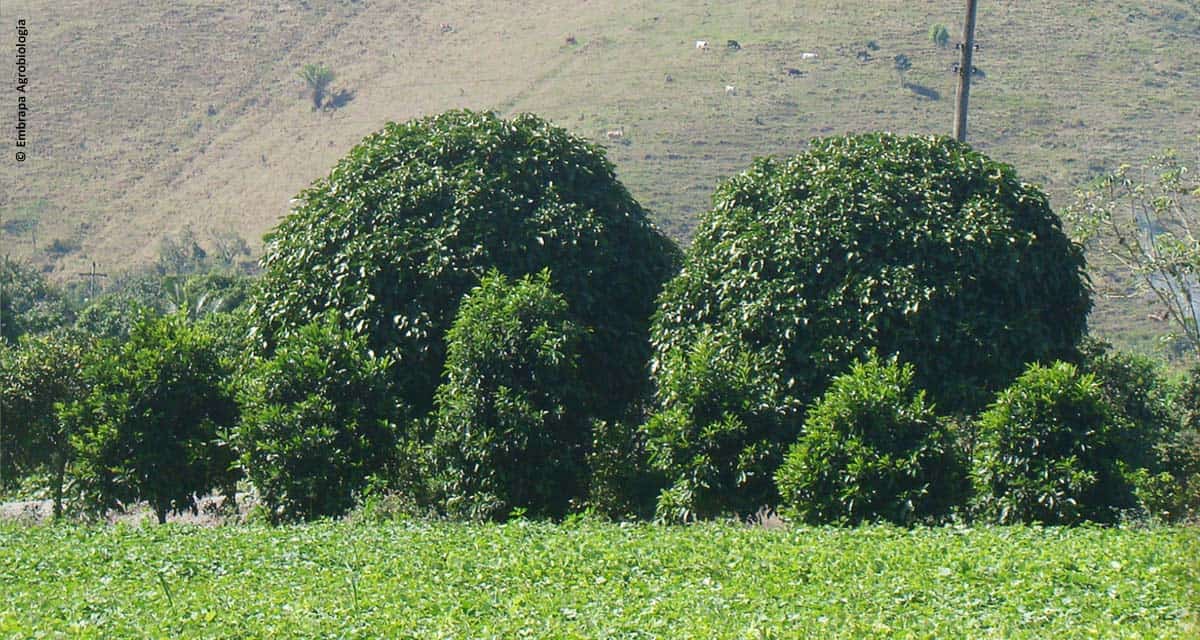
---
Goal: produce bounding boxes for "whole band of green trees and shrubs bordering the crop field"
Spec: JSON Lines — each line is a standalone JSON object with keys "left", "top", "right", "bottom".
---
{"left": 0, "top": 110, "right": 1200, "bottom": 525}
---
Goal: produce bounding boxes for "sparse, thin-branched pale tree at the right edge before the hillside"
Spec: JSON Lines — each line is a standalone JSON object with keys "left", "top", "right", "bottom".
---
{"left": 1066, "top": 145, "right": 1200, "bottom": 357}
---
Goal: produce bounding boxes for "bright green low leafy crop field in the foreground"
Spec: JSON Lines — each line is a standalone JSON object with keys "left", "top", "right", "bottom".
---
{"left": 0, "top": 522, "right": 1200, "bottom": 638}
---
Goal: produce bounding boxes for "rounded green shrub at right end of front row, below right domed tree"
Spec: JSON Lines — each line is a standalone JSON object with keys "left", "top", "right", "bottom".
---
{"left": 973, "top": 363, "right": 1140, "bottom": 525}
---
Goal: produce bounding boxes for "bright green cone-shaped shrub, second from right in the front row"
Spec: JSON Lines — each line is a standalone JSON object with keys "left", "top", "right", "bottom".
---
{"left": 775, "top": 357, "right": 968, "bottom": 525}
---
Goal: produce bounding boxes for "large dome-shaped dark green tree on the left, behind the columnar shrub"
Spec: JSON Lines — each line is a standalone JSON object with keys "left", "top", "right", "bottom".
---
{"left": 254, "top": 110, "right": 678, "bottom": 417}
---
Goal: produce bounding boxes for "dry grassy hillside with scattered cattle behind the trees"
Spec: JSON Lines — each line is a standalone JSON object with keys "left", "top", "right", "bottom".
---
{"left": 0, "top": 0, "right": 1200, "bottom": 348}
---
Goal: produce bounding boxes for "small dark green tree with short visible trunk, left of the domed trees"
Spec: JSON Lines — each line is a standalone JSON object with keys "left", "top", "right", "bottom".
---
{"left": 64, "top": 315, "right": 236, "bottom": 522}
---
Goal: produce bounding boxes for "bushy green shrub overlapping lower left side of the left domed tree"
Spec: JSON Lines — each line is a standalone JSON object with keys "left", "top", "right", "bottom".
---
{"left": 234, "top": 312, "right": 402, "bottom": 521}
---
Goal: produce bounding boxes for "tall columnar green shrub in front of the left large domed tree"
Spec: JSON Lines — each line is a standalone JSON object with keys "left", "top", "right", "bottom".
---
{"left": 433, "top": 271, "right": 590, "bottom": 520}
